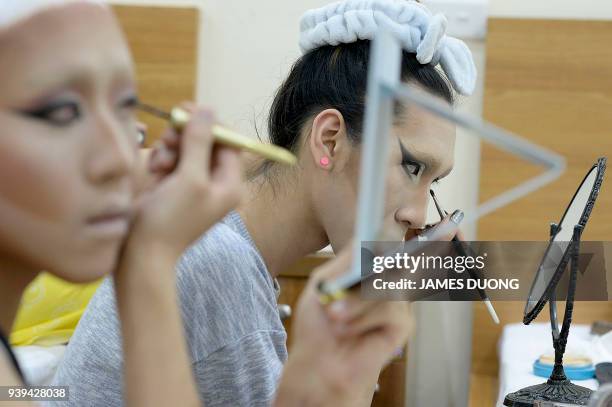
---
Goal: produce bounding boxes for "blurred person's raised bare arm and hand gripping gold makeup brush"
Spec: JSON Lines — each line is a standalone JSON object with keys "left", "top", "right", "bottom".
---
{"left": 115, "top": 110, "right": 242, "bottom": 406}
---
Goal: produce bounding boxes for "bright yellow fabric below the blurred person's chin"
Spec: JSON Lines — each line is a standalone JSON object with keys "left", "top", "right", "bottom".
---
{"left": 10, "top": 273, "right": 101, "bottom": 346}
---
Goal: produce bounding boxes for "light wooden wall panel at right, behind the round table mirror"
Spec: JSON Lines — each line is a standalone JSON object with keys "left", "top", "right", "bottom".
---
{"left": 470, "top": 19, "right": 612, "bottom": 407}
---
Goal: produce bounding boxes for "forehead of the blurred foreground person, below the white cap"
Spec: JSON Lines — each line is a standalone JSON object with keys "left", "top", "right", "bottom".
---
{"left": 0, "top": 3, "right": 132, "bottom": 99}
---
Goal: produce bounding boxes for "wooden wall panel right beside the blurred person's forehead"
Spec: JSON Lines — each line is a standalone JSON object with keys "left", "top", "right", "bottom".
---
{"left": 113, "top": 6, "right": 199, "bottom": 145}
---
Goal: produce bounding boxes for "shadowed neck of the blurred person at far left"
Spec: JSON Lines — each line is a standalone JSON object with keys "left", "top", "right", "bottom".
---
{"left": 0, "top": 256, "right": 38, "bottom": 335}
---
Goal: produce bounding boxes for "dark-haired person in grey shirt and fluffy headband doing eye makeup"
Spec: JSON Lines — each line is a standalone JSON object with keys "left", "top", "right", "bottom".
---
{"left": 54, "top": 0, "right": 476, "bottom": 406}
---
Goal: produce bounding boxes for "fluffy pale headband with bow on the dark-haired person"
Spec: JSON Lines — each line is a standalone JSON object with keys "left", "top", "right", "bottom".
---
{"left": 300, "top": 0, "right": 477, "bottom": 95}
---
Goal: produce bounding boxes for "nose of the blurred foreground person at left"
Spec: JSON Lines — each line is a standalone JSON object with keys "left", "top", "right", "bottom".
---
{"left": 86, "top": 109, "right": 137, "bottom": 183}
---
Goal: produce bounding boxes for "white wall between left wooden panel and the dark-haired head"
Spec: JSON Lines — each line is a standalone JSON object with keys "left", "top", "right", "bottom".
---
{"left": 112, "top": 0, "right": 328, "bottom": 135}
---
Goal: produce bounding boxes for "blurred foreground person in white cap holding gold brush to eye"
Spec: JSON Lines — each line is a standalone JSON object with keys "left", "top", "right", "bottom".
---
{"left": 0, "top": 0, "right": 243, "bottom": 406}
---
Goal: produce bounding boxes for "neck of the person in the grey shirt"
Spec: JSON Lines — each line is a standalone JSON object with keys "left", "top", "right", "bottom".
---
{"left": 238, "top": 175, "right": 328, "bottom": 277}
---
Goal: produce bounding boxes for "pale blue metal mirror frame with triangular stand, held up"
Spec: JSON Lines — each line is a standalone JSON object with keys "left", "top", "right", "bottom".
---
{"left": 319, "top": 28, "right": 565, "bottom": 303}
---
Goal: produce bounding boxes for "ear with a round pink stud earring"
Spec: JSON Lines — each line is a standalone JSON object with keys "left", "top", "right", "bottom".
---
{"left": 308, "top": 109, "right": 349, "bottom": 170}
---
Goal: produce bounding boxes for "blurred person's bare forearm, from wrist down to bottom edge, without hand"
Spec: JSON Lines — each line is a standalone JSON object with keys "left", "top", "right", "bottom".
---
{"left": 115, "top": 247, "right": 201, "bottom": 407}
